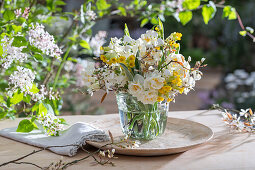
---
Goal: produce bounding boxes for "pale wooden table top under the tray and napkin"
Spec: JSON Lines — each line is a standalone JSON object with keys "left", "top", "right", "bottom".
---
{"left": 0, "top": 110, "right": 255, "bottom": 170}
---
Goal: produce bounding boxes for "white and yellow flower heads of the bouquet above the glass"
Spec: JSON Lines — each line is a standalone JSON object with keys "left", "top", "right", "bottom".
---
{"left": 79, "top": 21, "right": 204, "bottom": 104}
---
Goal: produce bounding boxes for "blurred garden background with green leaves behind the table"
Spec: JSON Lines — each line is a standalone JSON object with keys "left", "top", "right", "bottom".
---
{"left": 0, "top": 0, "right": 255, "bottom": 118}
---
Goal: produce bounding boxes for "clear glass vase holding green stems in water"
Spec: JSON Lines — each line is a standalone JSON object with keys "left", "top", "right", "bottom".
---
{"left": 116, "top": 93, "right": 169, "bottom": 140}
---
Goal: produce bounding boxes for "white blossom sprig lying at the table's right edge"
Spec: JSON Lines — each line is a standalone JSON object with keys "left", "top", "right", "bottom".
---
{"left": 213, "top": 104, "right": 255, "bottom": 132}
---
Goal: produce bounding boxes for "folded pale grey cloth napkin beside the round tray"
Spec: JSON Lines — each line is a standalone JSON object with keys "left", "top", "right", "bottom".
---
{"left": 0, "top": 123, "right": 109, "bottom": 156}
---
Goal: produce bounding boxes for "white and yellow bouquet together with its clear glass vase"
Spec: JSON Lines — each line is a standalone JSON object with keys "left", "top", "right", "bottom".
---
{"left": 80, "top": 21, "right": 205, "bottom": 139}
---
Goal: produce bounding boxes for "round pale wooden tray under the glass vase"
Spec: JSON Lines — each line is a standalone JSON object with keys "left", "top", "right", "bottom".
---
{"left": 87, "top": 118, "right": 213, "bottom": 156}
